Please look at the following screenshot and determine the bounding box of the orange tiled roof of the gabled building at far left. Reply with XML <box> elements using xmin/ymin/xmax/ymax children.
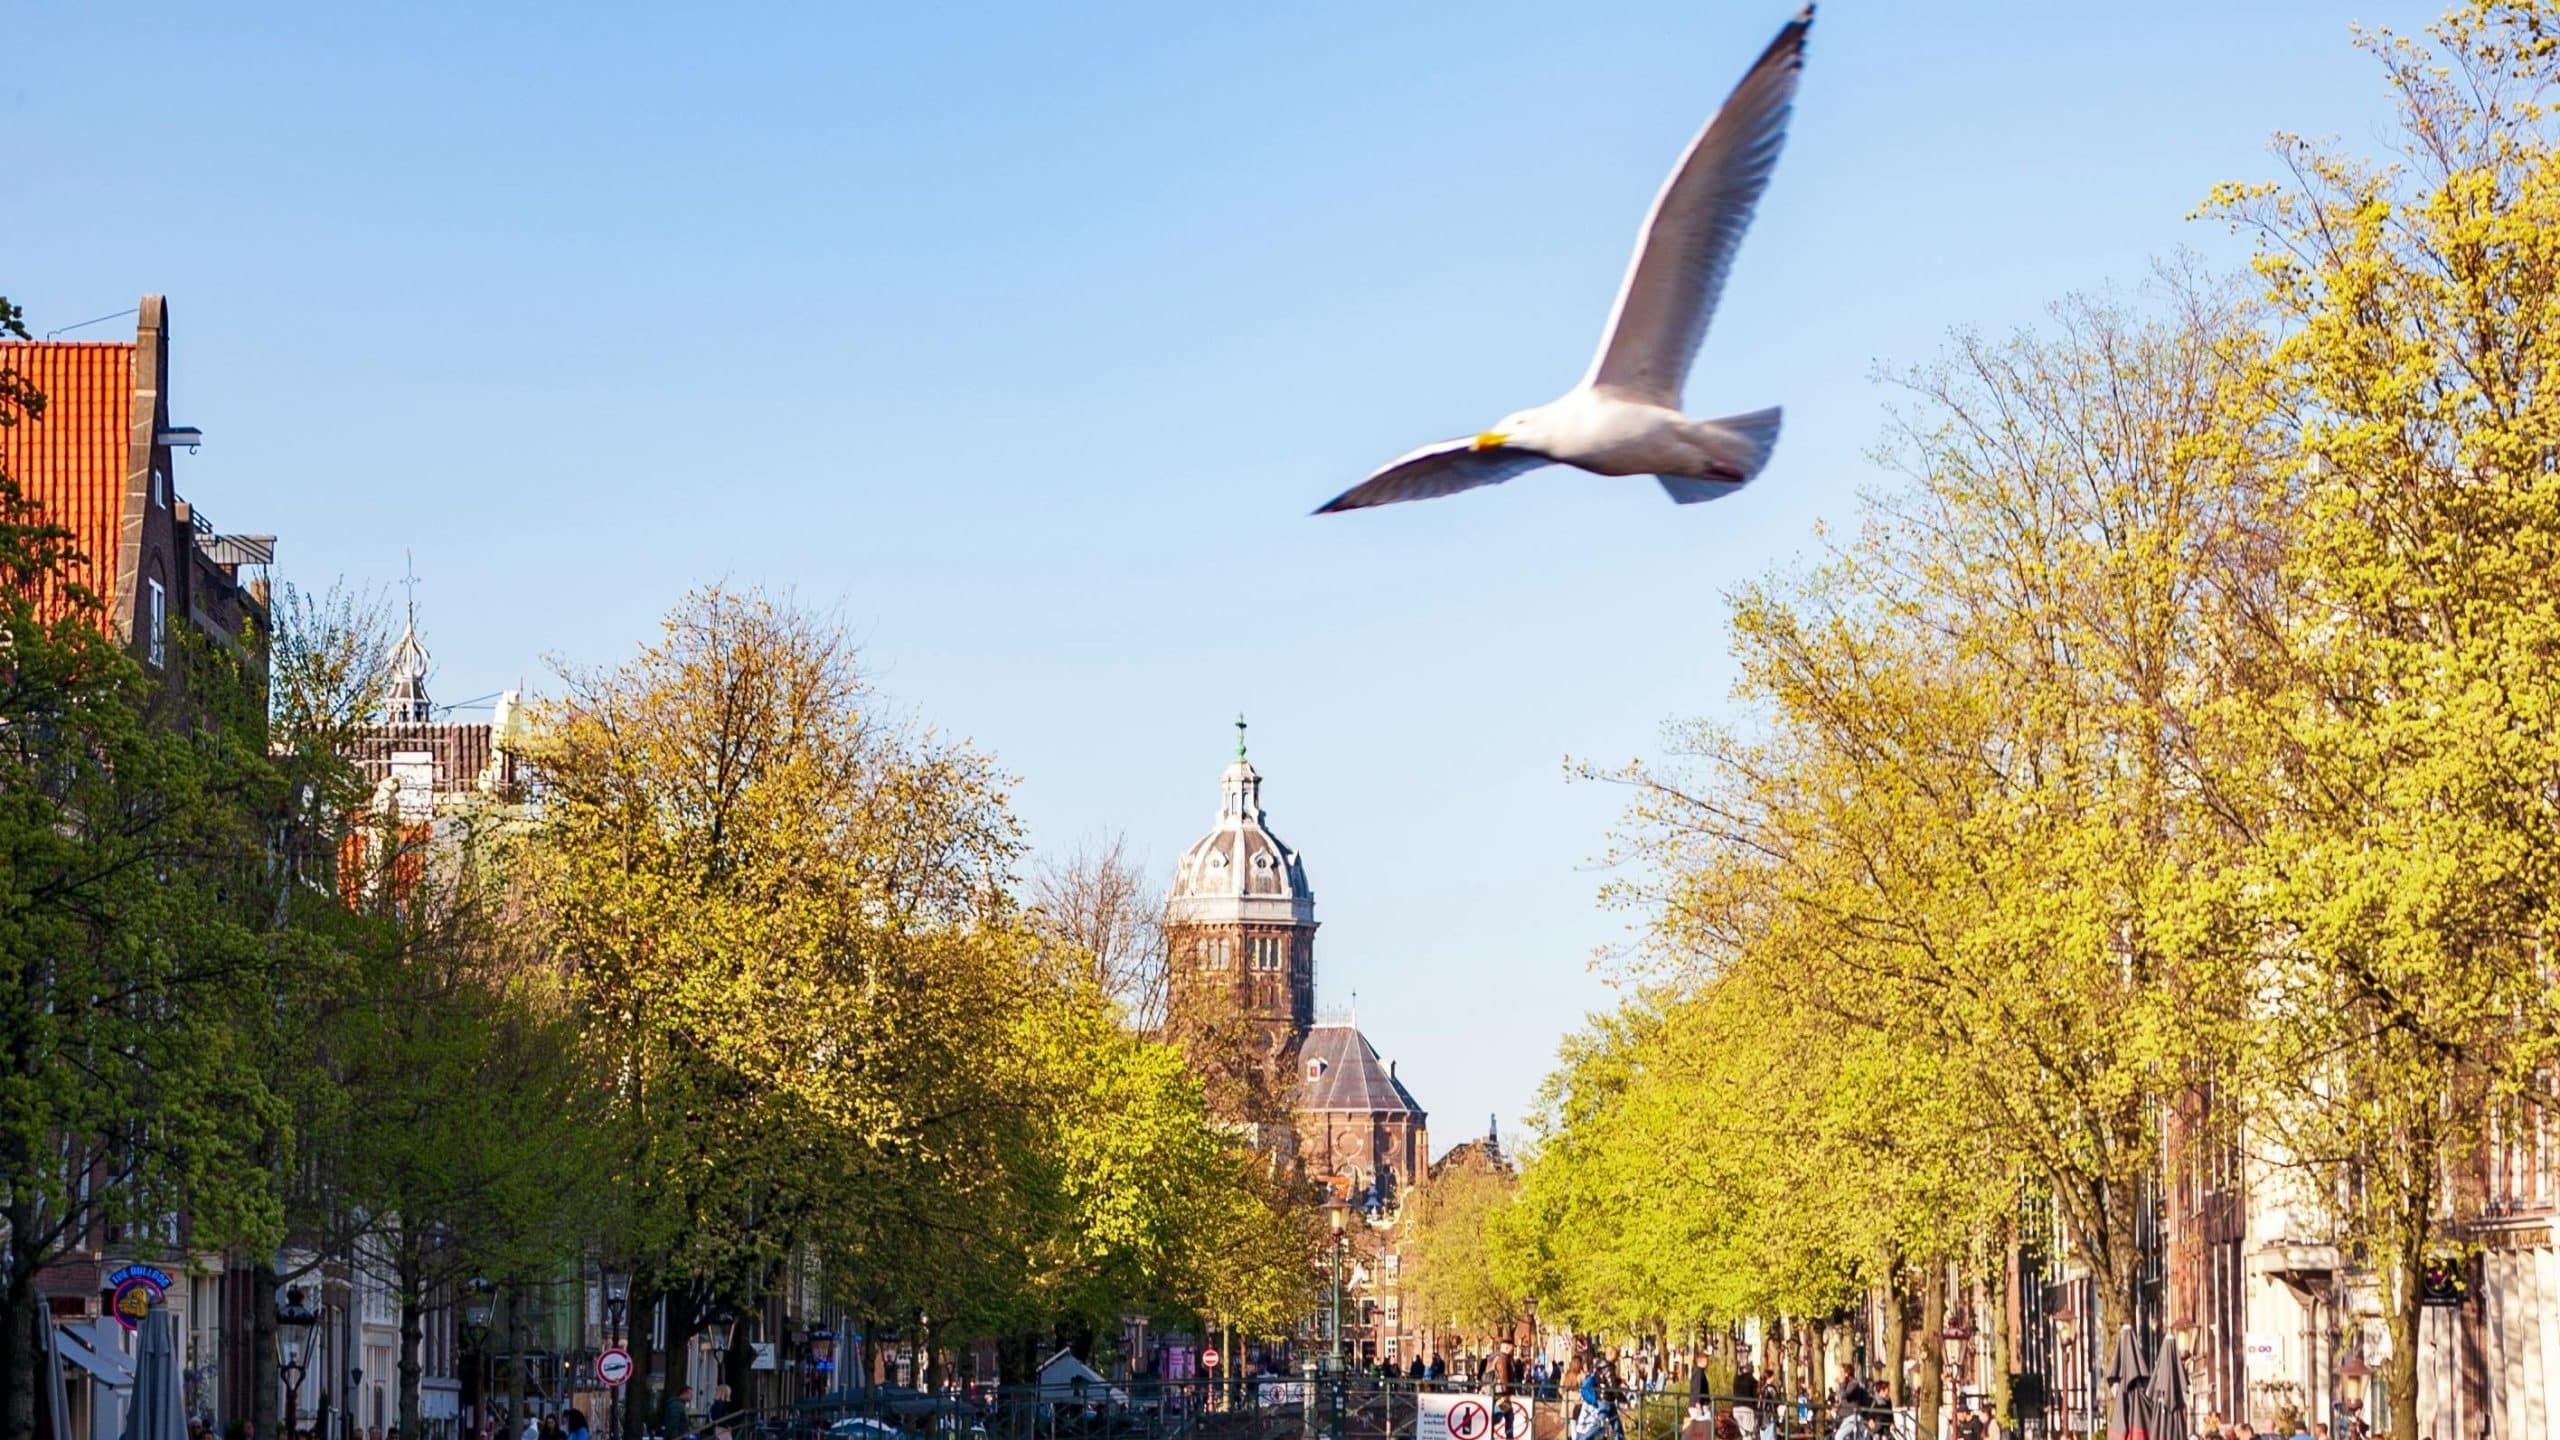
<box><xmin>0</xmin><ymin>341</ymin><xmax>133</xmax><ymax>615</ymax></box>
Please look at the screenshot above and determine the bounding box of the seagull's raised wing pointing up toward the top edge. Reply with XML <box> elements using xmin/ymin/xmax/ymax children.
<box><xmin>1582</xmin><ymin>5</ymin><xmax>1812</xmax><ymax>410</ymax></box>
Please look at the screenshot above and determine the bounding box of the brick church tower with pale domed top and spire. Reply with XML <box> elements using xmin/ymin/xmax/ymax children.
<box><xmin>1165</xmin><ymin>715</ymin><xmax>1316</xmax><ymax>1071</ymax></box>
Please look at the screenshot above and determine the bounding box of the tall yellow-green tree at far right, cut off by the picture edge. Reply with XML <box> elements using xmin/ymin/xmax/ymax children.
<box><xmin>2207</xmin><ymin>0</ymin><xmax>2560</xmax><ymax>1440</ymax></box>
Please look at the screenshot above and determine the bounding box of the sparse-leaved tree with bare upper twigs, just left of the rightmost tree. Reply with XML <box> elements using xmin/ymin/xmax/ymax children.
<box><xmin>1620</xmin><ymin>287</ymin><xmax>2258</xmax><ymax>1327</ymax></box>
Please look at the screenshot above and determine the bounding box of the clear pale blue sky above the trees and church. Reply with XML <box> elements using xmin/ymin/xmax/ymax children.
<box><xmin>0</xmin><ymin>0</ymin><xmax>2437</xmax><ymax>1148</ymax></box>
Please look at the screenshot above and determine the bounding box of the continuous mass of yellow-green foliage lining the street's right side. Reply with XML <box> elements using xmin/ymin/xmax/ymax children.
<box><xmin>1513</xmin><ymin>22</ymin><xmax>2560</xmax><ymax>1435</ymax></box>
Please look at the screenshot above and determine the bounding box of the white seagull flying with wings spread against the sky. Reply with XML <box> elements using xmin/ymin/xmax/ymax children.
<box><xmin>1316</xmin><ymin>5</ymin><xmax>1812</xmax><ymax>515</ymax></box>
